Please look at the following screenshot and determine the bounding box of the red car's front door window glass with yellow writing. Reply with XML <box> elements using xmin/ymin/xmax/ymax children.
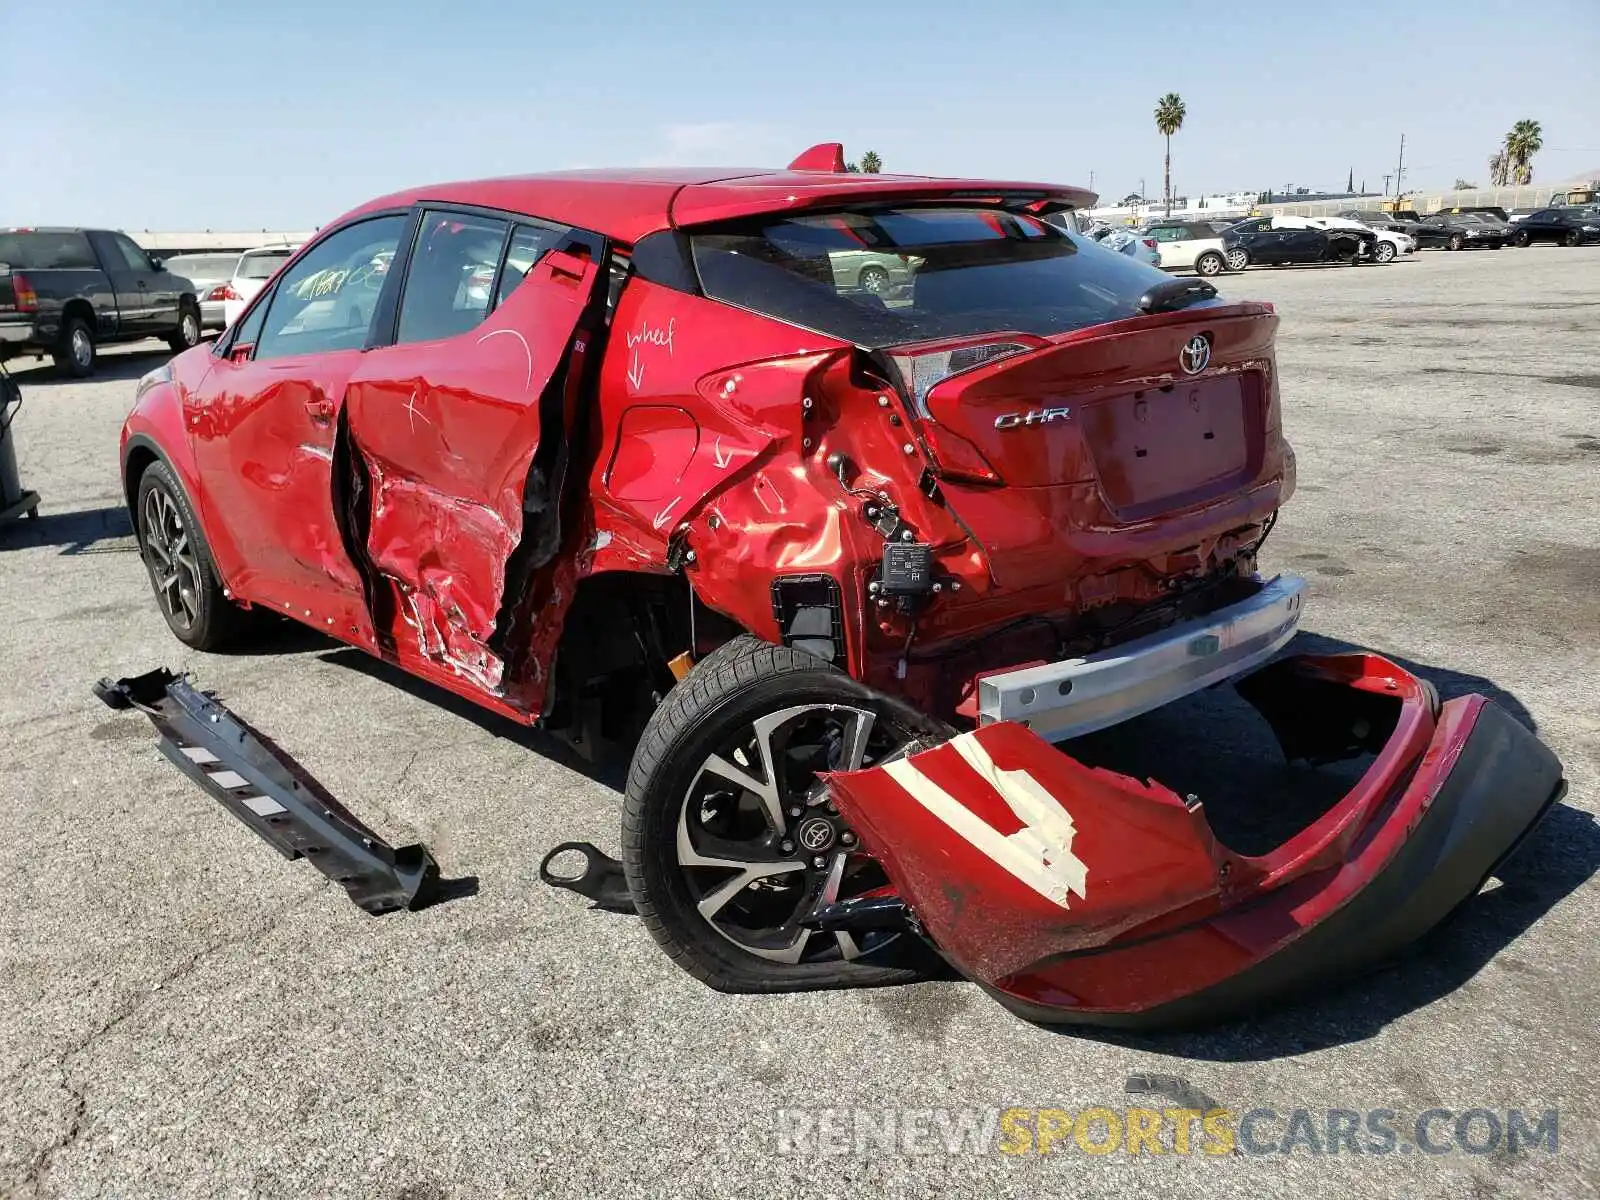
<box><xmin>256</xmin><ymin>216</ymin><xmax>406</xmax><ymax>360</ymax></box>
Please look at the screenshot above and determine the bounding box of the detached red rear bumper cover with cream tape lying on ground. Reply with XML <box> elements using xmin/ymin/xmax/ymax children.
<box><xmin>829</xmin><ymin>654</ymin><xmax>1565</xmax><ymax>1027</ymax></box>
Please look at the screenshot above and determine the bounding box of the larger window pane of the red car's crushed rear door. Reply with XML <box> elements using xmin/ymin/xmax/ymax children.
<box><xmin>395</xmin><ymin>213</ymin><xmax>510</xmax><ymax>344</ymax></box>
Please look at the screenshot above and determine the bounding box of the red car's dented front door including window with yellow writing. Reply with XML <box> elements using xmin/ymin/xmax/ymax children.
<box><xmin>186</xmin><ymin>213</ymin><xmax>408</xmax><ymax>646</ymax></box>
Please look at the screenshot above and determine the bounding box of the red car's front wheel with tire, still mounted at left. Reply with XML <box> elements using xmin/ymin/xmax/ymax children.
<box><xmin>134</xmin><ymin>461</ymin><xmax>251</xmax><ymax>650</ymax></box>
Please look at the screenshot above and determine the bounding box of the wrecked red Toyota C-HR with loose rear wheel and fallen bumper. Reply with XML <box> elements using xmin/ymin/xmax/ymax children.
<box><xmin>122</xmin><ymin>146</ymin><xmax>1562</xmax><ymax>1024</ymax></box>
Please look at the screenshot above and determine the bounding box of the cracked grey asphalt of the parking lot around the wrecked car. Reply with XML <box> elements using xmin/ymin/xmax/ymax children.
<box><xmin>0</xmin><ymin>248</ymin><xmax>1600</xmax><ymax>1200</ymax></box>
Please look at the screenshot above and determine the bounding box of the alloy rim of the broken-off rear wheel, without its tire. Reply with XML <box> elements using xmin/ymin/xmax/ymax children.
<box><xmin>677</xmin><ymin>704</ymin><xmax>910</xmax><ymax>963</ymax></box>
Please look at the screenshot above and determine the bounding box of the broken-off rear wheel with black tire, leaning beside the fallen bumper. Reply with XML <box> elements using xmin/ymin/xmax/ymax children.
<box><xmin>622</xmin><ymin>635</ymin><xmax>950</xmax><ymax>992</ymax></box>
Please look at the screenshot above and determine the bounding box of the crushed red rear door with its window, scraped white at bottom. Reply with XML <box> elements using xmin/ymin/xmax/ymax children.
<box><xmin>347</xmin><ymin>208</ymin><xmax>606</xmax><ymax>714</ymax></box>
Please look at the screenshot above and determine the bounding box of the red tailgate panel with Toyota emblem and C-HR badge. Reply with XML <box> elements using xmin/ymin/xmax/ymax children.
<box><xmin>896</xmin><ymin>304</ymin><xmax>1282</xmax><ymax>587</ymax></box>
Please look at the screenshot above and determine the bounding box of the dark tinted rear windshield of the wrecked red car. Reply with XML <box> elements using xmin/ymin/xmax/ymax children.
<box><xmin>691</xmin><ymin>206</ymin><xmax>1170</xmax><ymax>349</ymax></box>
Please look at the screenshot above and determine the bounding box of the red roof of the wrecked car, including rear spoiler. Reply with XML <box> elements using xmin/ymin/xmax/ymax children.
<box><xmin>341</xmin><ymin>166</ymin><xmax>1096</xmax><ymax>243</ymax></box>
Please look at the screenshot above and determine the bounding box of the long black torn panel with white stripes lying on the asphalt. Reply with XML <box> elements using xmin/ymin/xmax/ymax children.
<box><xmin>94</xmin><ymin>667</ymin><xmax>461</xmax><ymax>915</ymax></box>
